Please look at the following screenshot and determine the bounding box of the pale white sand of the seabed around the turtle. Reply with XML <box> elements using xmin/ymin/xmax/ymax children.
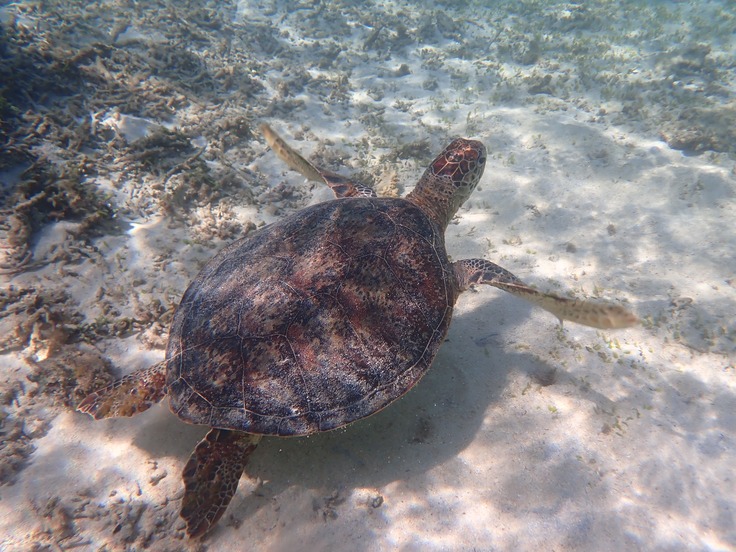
<box><xmin>0</xmin><ymin>1</ymin><xmax>736</xmax><ymax>551</ymax></box>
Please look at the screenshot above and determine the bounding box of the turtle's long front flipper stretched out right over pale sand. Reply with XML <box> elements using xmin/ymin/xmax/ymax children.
<box><xmin>453</xmin><ymin>259</ymin><xmax>639</xmax><ymax>330</ymax></box>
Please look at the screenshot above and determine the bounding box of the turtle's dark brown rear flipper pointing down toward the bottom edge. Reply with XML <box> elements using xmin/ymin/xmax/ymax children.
<box><xmin>179</xmin><ymin>429</ymin><xmax>261</xmax><ymax>538</ymax></box>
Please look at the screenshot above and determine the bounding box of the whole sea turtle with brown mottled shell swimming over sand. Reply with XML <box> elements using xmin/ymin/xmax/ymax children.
<box><xmin>78</xmin><ymin>125</ymin><xmax>637</xmax><ymax>537</ymax></box>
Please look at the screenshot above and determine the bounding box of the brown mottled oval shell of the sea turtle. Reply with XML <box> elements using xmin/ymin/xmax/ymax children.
<box><xmin>166</xmin><ymin>197</ymin><xmax>458</xmax><ymax>435</ymax></box>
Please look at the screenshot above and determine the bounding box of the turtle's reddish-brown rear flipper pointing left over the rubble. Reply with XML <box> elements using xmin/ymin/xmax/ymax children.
<box><xmin>77</xmin><ymin>360</ymin><xmax>166</xmax><ymax>420</ymax></box>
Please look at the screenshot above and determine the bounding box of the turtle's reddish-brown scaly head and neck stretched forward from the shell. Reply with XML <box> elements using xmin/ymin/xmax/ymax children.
<box><xmin>407</xmin><ymin>138</ymin><xmax>486</xmax><ymax>229</ymax></box>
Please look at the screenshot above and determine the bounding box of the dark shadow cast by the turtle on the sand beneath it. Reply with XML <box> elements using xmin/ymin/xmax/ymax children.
<box><xmin>133</xmin><ymin>294</ymin><xmax>556</xmax><ymax>538</ymax></box>
